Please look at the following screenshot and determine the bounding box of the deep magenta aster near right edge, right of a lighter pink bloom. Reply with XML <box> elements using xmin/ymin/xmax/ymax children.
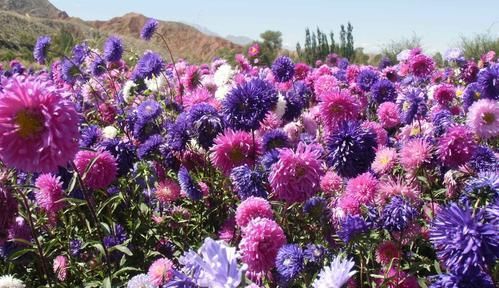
<box><xmin>438</xmin><ymin>126</ymin><xmax>476</xmax><ymax>168</ymax></box>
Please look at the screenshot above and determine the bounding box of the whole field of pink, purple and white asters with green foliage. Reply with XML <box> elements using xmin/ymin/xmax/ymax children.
<box><xmin>0</xmin><ymin>19</ymin><xmax>499</xmax><ymax>288</ymax></box>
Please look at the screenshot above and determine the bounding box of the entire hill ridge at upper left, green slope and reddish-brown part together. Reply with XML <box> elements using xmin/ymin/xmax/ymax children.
<box><xmin>0</xmin><ymin>0</ymin><xmax>242</xmax><ymax>63</ymax></box>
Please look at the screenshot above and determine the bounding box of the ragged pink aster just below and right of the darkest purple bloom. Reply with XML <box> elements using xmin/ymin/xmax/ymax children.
<box><xmin>345</xmin><ymin>172</ymin><xmax>378</xmax><ymax>204</ymax></box>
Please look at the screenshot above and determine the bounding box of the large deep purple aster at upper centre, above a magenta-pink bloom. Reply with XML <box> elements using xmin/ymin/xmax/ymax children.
<box><xmin>222</xmin><ymin>78</ymin><xmax>277</xmax><ymax>131</ymax></box>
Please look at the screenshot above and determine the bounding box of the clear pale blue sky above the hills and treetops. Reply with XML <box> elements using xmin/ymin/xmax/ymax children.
<box><xmin>50</xmin><ymin>0</ymin><xmax>499</xmax><ymax>52</ymax></box>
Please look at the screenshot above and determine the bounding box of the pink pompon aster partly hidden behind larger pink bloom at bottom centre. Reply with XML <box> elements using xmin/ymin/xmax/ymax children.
<box><xmin>236</xmin><ymin>196</ymin><xmax>274</xmax><ymax>227</ymax></box>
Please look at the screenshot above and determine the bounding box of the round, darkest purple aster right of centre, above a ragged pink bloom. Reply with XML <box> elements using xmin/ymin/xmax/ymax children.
<box><xmin>326</xmin><ymin>122</ymin><xmax>376</xmax><ymax>177</ymax></box>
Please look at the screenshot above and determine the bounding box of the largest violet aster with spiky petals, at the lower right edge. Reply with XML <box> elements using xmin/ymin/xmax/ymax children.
<box><xmin>430</xmin><ymin>203</ymin><xmax>499</xmax><ymax>275</ymax></box>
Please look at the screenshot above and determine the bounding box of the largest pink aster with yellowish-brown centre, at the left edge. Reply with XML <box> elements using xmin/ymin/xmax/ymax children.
<box><xmin>0</xmin><ymin>77</ymin><xmax>79</xmax><ymax>172</ymax></box>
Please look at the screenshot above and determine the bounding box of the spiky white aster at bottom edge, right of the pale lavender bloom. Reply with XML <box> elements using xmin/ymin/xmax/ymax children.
<box><xmin>312</xmin><ymin>256</ymin><xmax>357</xmax><ymax>288</ymax></box>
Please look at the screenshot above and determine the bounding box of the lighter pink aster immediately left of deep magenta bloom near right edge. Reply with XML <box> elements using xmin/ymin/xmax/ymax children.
<box><xmin>400</xmin><ymin>138</ymin><xmax>431</xmax><ymax>171</ymax></box>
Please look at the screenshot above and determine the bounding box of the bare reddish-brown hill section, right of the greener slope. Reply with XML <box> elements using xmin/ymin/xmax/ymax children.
<box><xmin>92</xmin><ymin>13</ymin><xmax>242</xmax><ymax>62</ymax></box>
